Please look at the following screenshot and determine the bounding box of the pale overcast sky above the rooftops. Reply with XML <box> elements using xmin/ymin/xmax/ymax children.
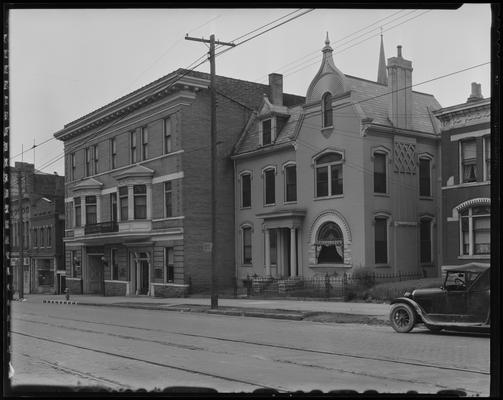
<box><xmin>9</xmin><ymin>3</ymin><xmax>491</xmax><ymax>175</ymax></box>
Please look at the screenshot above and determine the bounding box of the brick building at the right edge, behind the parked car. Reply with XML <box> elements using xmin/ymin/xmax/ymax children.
<box><xmin>435</xmin><ymin>83</ymin><xmax>491</xmax><ymax>265</ymax></box>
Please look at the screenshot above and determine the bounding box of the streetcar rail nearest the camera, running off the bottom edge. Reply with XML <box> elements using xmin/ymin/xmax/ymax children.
<box><xmin>11</xmin><ymin>331</ymin><xmax>288</xmax><ymax>392</ymax></box>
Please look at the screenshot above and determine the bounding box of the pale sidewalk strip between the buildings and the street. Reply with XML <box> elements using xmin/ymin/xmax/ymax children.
<box><xmin>16</xmin><ymin>294</ymin><xmax>390</xmax><ymax>325</ymax></box>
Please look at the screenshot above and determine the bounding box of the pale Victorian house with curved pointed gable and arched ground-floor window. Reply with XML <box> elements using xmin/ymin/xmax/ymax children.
<box><xmin>232</xmin><ymin>36</ymin><xmax>441</xmax><ymax>278</ymax></box>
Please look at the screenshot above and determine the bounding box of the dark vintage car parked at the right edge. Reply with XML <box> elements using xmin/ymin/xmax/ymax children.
<box><xmin>390</xmin><ymin>262</ymin><xmax>490</xmax><ymax>332</ymax></box>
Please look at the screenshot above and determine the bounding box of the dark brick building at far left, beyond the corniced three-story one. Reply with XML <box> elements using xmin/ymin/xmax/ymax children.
<box><xmin>10</xmin><ymin>162</ymin><xmax>64</xmax><ymax>293</ymax></box>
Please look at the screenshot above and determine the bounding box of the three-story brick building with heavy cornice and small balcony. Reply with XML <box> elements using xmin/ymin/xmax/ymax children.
<box><xmin>54</xmin><ymin>70</ymin><xmax>301</xmax><ymax>296</ymax></box>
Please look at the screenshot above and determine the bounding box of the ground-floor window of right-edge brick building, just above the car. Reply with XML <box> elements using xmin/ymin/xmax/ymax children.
<box><xmin>460</xmin><ymin>206</ymin><xmax>491</xmax><ymax>255</ymax></box>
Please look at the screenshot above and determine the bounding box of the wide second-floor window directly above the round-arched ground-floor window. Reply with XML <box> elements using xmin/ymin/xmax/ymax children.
<box><xmin>316</xmin><ymin>153</ymin><xmax>343</xmax><ymax>197</ymax></box>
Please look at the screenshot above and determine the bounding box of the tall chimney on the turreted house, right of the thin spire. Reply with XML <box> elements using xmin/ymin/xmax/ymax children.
<box><xmin>387</xmin><ymin>45</ymin><xmax>412</xmax><ymax>129</ymax></box>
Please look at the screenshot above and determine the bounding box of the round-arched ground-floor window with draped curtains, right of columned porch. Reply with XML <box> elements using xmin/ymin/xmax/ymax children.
<box><xmin>315</xmin><ymin>222</ymin><xmax>344</xmax><ymax>264</ymax></box>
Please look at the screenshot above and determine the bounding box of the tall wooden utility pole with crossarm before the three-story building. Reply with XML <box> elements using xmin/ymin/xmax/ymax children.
<box><xmin>185</xmin><ymin>34</ymin><xmax>235</xmax><ymax>309</ymax></box>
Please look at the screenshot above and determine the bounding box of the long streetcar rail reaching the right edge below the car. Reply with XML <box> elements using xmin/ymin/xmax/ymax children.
<box><xmin>13</xmin><ymin>313</ymin><xmax>490</xmax><ymax>375</ymax></box>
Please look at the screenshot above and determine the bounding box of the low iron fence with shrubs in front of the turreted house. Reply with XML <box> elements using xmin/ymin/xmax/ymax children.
<box><xmin>243</xmin><ymin>272</ymin><xmax>424</xmax><ymax>298</ymax></box>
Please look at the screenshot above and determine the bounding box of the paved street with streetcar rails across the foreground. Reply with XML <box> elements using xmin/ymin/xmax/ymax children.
<box><xmin>7</xmin><ymin>302</ymin><xmax>490</xmax><ymax>396</ymax></box>
